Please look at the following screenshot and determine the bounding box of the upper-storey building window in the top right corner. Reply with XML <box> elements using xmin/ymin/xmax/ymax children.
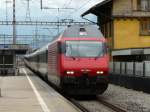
<box><xmin>138</xmin><ymin>0</ymin><xmax>150</xmax><ymax>11</ymax></box>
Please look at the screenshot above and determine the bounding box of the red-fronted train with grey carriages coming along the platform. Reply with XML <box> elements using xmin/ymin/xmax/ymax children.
<box><xmin>24</xmin><ymin>25</ymin><xmax>109</xmax><ymax>95</ymax></box>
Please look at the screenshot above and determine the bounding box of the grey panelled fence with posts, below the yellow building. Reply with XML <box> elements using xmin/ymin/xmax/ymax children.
<box><xmin>110</xmin><ymin>61</ymin><xmax>150</xmax><ymax>77</ymax></box>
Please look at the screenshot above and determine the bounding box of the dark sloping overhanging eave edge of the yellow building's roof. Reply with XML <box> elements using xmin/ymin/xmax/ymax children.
<box><xmin>81</xmin><ymin>0</ymin><xmax>112</xmax><ymax>17</ymax></box>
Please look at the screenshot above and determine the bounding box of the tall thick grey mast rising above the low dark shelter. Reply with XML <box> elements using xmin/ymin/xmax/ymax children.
<box><xmin>13</xmin><ymin>0</ymin><xmax>16</xmax><ymax>44</ymax></box>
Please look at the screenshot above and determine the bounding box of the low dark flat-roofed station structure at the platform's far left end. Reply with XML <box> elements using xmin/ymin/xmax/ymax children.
<box><xmin>0</xmin><ymin>44</ymin><xmax>30</xmax><ymax>75</ymax></box>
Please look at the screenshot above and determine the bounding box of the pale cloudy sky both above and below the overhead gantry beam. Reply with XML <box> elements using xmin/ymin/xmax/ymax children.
<box><xmin>0</xmin><ymin>0</ymin><xmax>103</xmax><ymax>46</ymax></box>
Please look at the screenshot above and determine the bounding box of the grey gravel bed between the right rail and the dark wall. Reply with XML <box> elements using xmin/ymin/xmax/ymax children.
<box><xmin>99</xmin><ymin>84</ymin><xmax>150</xmax><ymax>112</ymax></box>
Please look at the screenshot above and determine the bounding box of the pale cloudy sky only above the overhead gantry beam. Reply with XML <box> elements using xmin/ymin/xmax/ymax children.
<box><xmin>0</xmin><ymin>0</ymin><xmax>102</xmax><ymax>21</ymax></box>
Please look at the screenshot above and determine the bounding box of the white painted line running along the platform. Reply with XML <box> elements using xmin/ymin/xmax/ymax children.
<box><xmin>23</xmin><ymin>68</ymin><xmax>50</xmax><ymax>112</ymax></box>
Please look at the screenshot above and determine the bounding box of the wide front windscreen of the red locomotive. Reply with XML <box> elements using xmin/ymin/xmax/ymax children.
<box><xmin>66</xmin><ymin>41</ymin><xmax>104</xmax><ymax>57</ymax></box>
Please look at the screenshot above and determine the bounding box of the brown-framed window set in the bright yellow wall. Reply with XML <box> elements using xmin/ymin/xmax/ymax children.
<box><xmin>140</xmin><ymin>20</ymin><xmax>150</xmax><ymax>36</ymax></box>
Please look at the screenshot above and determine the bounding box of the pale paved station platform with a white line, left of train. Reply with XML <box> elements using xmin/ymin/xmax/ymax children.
<box><xmin>0</xmin><ymin>68</ymin><xmax>80</xmax><ymax>112</ymax></box>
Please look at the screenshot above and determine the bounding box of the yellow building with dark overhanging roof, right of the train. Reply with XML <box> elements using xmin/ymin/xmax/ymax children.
<box><xmin>82</xmin><ymin>0</ymin><xmax>150</xmax><ymax>61</ymax></box>
